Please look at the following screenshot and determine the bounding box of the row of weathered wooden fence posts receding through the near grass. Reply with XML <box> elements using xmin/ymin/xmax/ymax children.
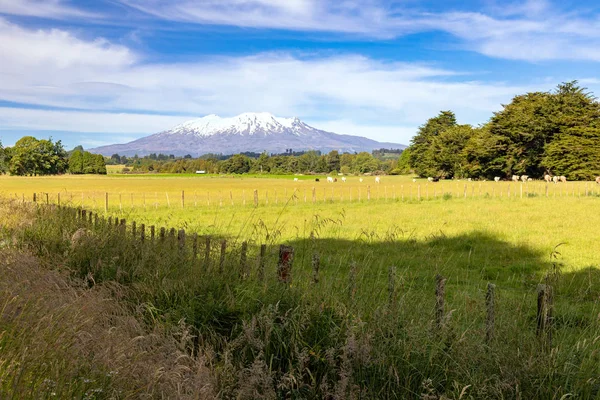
<box><xmin>14</xmin><ymin>202</ymin><xmax>572</xmax><ymax>348</ymax></box>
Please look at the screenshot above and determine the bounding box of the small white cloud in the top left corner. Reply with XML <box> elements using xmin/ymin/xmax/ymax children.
<box><xmin>0</xmin><ymin>0</ymin><xmax>94</xmax><ymax>19</ymax></box>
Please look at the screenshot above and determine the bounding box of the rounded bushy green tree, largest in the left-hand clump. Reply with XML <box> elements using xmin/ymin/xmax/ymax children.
<box><xmin>8</xmin><ymin>136</ymin><xmax>68</xmax><ymax>176</ymax></box>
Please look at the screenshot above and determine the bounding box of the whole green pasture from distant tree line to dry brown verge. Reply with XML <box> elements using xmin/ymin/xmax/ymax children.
<box><xmin>0</xmin><ymin>175</ymin><xmax>600</xmax><ymax>399</ymax></box>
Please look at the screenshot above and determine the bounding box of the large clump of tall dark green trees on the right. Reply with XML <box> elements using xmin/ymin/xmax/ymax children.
<box><xmin>408</xmin><ymin>81</ymin><xmax>600</xmax><ymax>180</ymax></box>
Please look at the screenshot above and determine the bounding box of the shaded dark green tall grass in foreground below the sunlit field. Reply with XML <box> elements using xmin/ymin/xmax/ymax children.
<box><xmin>3</xmin><ymin>202</ymin><xmax>600</xmax><ymax>399</ymax></box>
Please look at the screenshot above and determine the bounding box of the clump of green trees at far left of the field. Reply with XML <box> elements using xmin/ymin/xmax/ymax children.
<box><xmin>0</xmin><ymin>136</ymin><xmax>106</xmax><ymax>176</ymax></box>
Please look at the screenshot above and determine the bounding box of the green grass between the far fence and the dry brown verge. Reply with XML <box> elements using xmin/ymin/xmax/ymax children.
<box><xmin>0</xmin><ymin>177</ymin><xmax>600</xmax><ymax>399</ymax></box>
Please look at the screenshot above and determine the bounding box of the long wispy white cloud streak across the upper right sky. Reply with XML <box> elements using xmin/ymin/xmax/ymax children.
<box><xmin>115</xmin><ymin>0</ymin><xmax>600</xmax><ymax>61</ymax></box>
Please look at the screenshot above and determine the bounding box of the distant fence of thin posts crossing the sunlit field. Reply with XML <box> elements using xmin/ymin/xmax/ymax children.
<box><xmin>8</xmin><ymin>182</ymin><xmax>600</xmax><ymax>213</ymax></box>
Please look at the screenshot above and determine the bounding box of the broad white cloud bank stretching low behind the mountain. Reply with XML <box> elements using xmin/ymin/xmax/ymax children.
<box><xmin>0</xmin><ymin>19</ymin><xmax>547</xmax><ymax>143</ymax></box>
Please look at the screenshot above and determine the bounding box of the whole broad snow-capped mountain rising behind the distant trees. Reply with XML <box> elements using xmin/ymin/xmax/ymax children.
<box><xmin>90</xmin><ymin>113</ymin><xmax>406</xmax><ymax>156</ymax></box>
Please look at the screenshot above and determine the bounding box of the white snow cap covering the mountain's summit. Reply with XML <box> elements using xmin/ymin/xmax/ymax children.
<box><xmin>165</xmin><ymin>112</ymin><xmax>307</xmax><ymax>136</ymax></box>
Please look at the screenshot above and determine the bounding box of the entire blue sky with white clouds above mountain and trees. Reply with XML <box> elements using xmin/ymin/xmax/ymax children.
<box><xmin>0</xmin><ymin>0</ymin><xmax>600</xmax><ymax>148</ymax></box>
